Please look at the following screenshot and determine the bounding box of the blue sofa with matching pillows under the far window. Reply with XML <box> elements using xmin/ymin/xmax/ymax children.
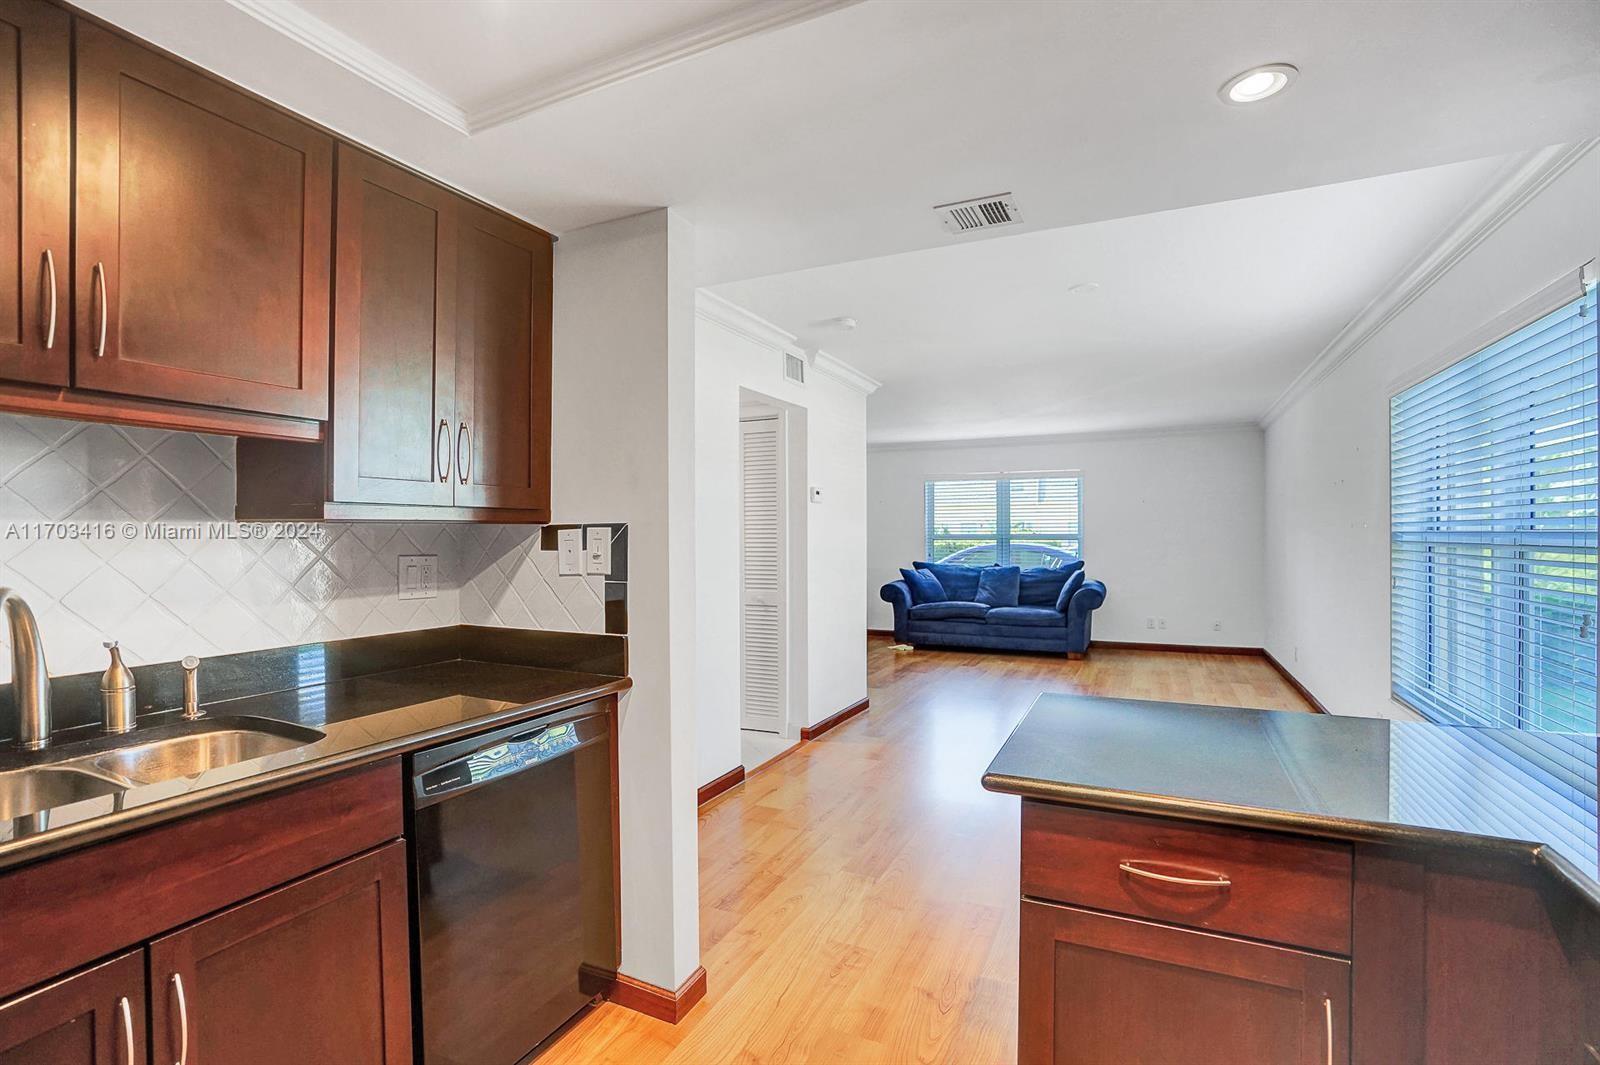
<box><xmin>878</xmin><ymin>558</ymin><xmax>1106</xmax><ymax>659</ymax></box>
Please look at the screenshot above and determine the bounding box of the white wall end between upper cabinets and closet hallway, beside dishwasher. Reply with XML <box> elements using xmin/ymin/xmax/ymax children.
<box><xmin>550</xmin><ymin>211</ymin><xmax>699</xmax><ymax>988</ymax></box>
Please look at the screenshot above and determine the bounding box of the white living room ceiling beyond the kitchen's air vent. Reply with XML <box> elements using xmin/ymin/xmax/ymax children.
<box><xmin>714</xmin><ymin>158</ymin><xmax>1509</xmax><ymax>443</ymax></box>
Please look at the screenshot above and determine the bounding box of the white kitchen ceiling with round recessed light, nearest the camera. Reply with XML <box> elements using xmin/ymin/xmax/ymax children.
<box><xmin>78</xmin><ymin>0</ymin><xmax>1600</xmax><ymax>283</ymax></box>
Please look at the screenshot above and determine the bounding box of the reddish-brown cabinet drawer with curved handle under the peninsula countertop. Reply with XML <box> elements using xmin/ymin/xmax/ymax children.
<box><xmin>1022</xmin><ymin>801</ymin><xmax>1350</xmax><ymax>955</ymax></box>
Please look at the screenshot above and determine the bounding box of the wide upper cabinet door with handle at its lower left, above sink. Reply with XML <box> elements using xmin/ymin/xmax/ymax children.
<box><xmin>72</xmin><ymin>19</ymin><xmax>333</xmax><ymax>419</ymax></box>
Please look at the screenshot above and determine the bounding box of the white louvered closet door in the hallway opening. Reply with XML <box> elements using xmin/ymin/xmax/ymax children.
<box><xmin>739</xmin><ymin>417</ymin><xmax>787</xmax><ymax>732</ymax></box>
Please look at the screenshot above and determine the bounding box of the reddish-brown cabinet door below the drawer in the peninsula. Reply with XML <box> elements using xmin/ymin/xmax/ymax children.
<box><xmin>1018</xmin><ymin>900</ymin><xmax>1350</xmax><ymax>1065</ymax></box>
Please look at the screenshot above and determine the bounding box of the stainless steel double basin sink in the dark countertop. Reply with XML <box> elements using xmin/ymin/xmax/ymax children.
<box><xmin>0</xmin><ymin>716</ymin><xmax>323</xmax><ymax>820</ymax></box>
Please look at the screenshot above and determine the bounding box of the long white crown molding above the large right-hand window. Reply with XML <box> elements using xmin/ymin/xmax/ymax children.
<box><xmin>1261</xmin><ymin>138</ymin><xmax>1600</xmax><ymax>427</ymax></box>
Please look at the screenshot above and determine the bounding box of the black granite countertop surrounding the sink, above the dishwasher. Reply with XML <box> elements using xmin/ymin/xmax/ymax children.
<box><xmin>0</xmin><ymin>627</ymin><xmax>632</xmax><ymax>868</ymax></box>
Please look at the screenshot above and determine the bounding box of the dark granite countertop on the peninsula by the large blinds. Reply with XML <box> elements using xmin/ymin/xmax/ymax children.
<box><xmin>984</xmin><ymin>694</ymin><xmax>1600</xmax><ymax>908</ymax></box>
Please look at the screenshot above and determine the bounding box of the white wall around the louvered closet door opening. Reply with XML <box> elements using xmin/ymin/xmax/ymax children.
<box><xmin>694</xmin><ymin>294</ymin><xmax>867</xmax><ymax>784</ymax></box>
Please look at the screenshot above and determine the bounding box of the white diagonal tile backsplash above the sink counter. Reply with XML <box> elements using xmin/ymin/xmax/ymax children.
<box><xmin>0</xmin><ymin>414</ymin><xmax>617</xmax><ymax>680</ymax></box>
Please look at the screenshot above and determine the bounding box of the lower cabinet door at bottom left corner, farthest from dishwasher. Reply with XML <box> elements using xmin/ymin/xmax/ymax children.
<box><xmin>0</xmin><ymin>950</ymin><xmax>146</xmax><ymax>1065</ymax></box>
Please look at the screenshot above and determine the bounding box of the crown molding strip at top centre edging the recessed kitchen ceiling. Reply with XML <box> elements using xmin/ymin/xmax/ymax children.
<box><xmin>464</xmin><ymin>0</ymin><xmax>861</xmax><ymax>133</ymax></box>
